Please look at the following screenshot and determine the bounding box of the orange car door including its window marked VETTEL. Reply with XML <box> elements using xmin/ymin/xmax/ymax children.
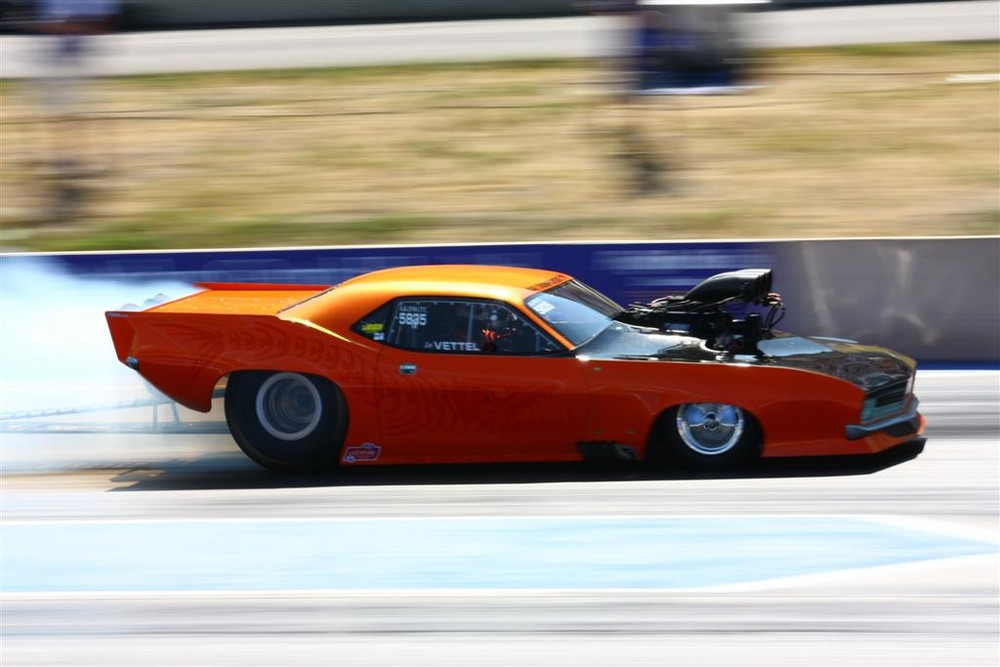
<box><xmin>376</xmin><ymin>297</ymin><xmax>586</xmax><ymax>462</ymax></box>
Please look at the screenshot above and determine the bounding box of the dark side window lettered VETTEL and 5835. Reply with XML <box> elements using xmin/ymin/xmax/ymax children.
<box><xmin>383</xmin><ymin>298</ymin><xmax>561</xmax><ymax>355</ymax></box>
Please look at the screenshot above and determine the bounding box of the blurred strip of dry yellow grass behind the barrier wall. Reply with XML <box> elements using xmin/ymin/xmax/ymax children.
<box><xmin>0</xmin><ymin>44</ymin><xmax>1000</xmax><ymax>250</ymax></box>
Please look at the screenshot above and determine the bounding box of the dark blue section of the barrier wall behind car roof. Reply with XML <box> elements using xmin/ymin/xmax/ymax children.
<box><xmin>5</xmin><ymin>242</ymin><xmax>774</xmax><ymax>303</ymax></box>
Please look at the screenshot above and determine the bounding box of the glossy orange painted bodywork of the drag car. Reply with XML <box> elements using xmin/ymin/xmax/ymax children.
<box><xmin>107</xmin><ymin>266</ymin><xmax>923</xmax><ymax>465</ymax></box>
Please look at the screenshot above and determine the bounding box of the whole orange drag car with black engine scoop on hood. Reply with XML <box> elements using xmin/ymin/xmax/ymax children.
<box><xmin>106</xmin><ymin>266</ymin><xmax>923</xmax><ymax>470</ymax></box>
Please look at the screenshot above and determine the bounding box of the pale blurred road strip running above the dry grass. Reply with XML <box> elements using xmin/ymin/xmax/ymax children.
<box><xmin>0</xmin><ymin>0</ymin><xmax>1000</xmax><ymax>79</ymax></box>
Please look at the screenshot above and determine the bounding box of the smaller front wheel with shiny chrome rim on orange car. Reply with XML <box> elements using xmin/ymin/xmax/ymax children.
<box><xmin>650</xmin><ymin>403</ymin><xmax>763</xmax><ymax>468</ymax></box>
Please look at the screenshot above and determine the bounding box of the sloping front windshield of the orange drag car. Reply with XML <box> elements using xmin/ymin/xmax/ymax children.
<box><xmin>525</xmin><ymin>280</ymin><xmax>622</xmax><ymax>347</ymax></box>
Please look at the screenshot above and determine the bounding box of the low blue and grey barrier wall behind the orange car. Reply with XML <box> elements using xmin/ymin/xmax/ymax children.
<box><xmin>0</xmin><ymin>237</ymin><xmax>1000</xmax><ymax>364</ymax></box>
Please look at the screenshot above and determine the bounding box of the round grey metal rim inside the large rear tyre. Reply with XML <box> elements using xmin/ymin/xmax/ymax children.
<box><xmin>256</xmin><ymin>373</ymin><xmax>323</xmax><ymax>442</ymax></box>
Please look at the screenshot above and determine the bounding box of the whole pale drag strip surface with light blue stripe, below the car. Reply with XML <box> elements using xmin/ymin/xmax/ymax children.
<box><xmin>0</xmin><ymin>371</ymin><xmax>1000</xmax><ymax>667</ymax></box>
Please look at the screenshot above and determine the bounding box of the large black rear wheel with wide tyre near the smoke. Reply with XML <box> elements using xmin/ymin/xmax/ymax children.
<box><xmin>225</xmin><ymin>371</ymin><xmax>347</xmax><ymax>471</ymax></box>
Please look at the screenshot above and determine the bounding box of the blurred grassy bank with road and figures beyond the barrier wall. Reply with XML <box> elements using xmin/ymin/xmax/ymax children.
<box><xmin>0</xmin><ymin>0</ymin><xmax>1000</xmax><ymax>251</ymax></box>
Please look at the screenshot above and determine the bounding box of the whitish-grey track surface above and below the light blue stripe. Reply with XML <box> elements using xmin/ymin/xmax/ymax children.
<box><xmin>3</xmin><ymin>438</ymin><xmax>998</xmax><ymax>667</ymax></box>
